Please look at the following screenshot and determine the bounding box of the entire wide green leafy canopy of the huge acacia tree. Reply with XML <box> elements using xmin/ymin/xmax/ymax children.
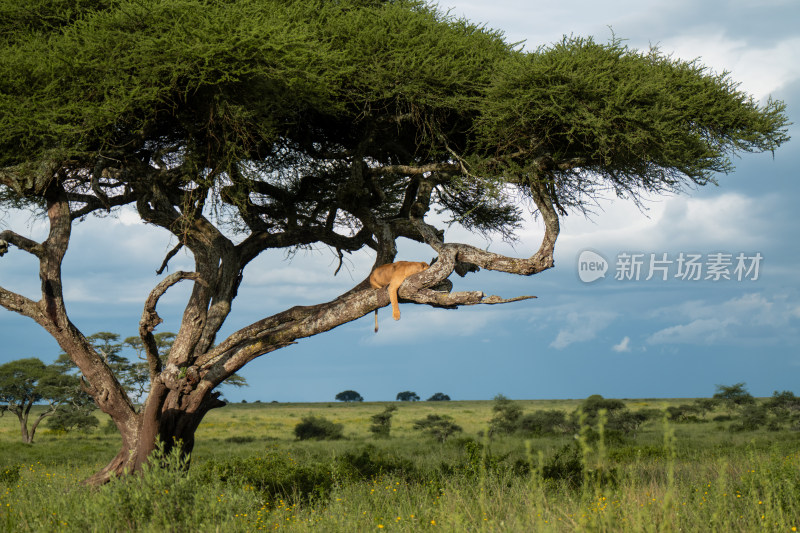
<box><xmin>0</xmin><ymin>0</ymin><xmax>788</xmax><ymax>236</ymax></box>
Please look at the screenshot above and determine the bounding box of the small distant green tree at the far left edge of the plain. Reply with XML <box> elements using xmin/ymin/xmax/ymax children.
<box><xmin>0</xmin><ymin>358</ymin><xmax>81</xmax><ymax>443</ymax></box>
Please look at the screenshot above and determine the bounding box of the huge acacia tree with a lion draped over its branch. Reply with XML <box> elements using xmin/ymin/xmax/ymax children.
<box><xmin>0</xmin><ymin>0</ymin><xmax>787</xmax><ymax>483</ymax></box>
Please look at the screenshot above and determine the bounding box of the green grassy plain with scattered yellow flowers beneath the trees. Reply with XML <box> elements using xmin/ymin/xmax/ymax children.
<box><xmin>0</xmin><ymin>399</ymin><xmax>800</xmax><ymax>532</ymax></box>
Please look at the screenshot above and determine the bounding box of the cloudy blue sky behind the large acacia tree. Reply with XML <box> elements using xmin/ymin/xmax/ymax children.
<box><xmin>0</xmin><ymin>0</ymin><xmax>800</xmax><ymax>402</ymax></box>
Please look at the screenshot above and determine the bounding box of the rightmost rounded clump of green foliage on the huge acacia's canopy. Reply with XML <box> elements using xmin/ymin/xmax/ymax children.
<box><xmin>479</xmin><ymin>37</ymin><xmax>788</xmax><ymax>206</ymax></box>
